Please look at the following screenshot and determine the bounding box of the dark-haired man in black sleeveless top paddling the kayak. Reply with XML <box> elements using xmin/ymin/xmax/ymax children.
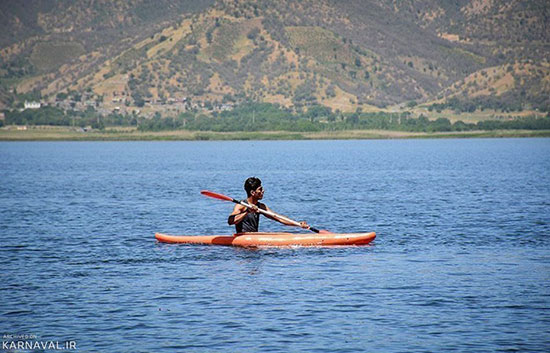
<box><xmin>227</xmin><ymin>177</ymin><xmax>309</xmax><ymax>233</ymax></box>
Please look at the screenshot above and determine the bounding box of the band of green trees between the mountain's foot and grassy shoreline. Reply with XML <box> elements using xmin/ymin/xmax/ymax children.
<box><xmin>5</xmin><ymin>103</ymin><xmax>550</xmax><ymax>139</ymax></box>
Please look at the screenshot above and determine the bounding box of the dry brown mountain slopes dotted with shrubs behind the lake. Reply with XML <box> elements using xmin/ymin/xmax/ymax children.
<box><xmin>0</xmin><ymin>0</ymin><xmax>550</xmax><ymax>111</ymax></box>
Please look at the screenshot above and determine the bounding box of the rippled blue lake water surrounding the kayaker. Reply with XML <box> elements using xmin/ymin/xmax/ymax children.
<box><xmin>0</xmin><ymin>139</ymin><xmax>550</xmax><ymax>352</ymax></box>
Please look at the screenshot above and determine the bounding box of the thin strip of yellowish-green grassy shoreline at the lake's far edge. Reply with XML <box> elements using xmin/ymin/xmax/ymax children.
<box><xmin>0</xmin><ymin>127</ymin><xmax>550</xmax><ymax>141</ymax></box>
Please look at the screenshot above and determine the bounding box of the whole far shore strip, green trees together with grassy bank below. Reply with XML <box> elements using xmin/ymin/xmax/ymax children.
<box><xmin>0</xmin><ymin>103</ymin><xmax>550</xmax><ymax>140</ymax></box>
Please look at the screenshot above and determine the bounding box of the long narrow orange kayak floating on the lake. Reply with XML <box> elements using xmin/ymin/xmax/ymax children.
<box><xmin>155</xmin><ymin>232</ymin><xmax>376</xmax><ymax>247</ymax></box>
